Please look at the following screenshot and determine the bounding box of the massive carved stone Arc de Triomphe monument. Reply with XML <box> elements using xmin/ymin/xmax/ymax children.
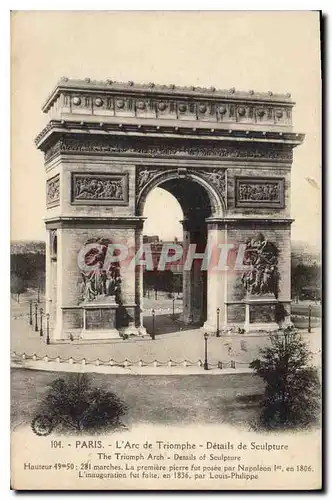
<box><xmin>36</xmin><ymin>78</ymin><xmax>304</xmax><ymax>342</ymax></box>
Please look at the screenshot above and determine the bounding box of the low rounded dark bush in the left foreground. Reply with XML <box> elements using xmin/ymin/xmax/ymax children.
<box><xmin>38</xmin><ymin>373</ymin><xmax>126</xmax><ymax>433</ymax></box>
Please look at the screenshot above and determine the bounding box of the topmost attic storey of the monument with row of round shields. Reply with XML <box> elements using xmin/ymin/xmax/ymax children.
<box><xmin>38</xmin><ymin>78</ymin><xmax>294</xmax><ymax>128</ymax></box>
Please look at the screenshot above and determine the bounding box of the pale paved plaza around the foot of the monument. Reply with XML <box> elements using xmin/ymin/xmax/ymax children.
<box><xmin>11</xmin><ymin>295</ymin><xmax>321</xmax><ymax>373</ymax></box>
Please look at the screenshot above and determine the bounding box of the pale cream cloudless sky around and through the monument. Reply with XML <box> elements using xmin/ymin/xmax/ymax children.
<box><xmin>11</xmin><ymin>11</ymin><xmax>321</xmax><ymax>246</ymax></box>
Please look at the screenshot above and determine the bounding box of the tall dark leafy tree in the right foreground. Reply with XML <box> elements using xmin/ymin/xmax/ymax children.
<box><xmin>250</xmin><ymin>327</ymin><xmax>320</xmax><ymax>428</ymax></box>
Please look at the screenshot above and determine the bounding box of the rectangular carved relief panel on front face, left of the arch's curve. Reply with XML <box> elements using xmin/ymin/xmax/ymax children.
<box><xmin>71</xmin><ymin>172</ymin><xmax>128</xmax><ymax>205</ymax></box>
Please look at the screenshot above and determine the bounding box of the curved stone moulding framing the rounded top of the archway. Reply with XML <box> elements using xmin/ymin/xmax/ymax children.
<box><xmin>136</xmin><ymin>168</ymin><xmax>226</xmax><ymax>217</ymax></box>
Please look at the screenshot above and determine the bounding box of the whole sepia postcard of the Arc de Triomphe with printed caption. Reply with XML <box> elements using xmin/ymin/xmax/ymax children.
<box><xmin>10</xmin><ymin>11</ymin><xmax>322</xmax><ymax>491</ymax></box>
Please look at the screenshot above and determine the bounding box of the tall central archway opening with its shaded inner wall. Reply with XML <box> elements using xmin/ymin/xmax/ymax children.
<box><xmin>142</xmin><ymin>178</ymin><xmax>212</xmax><ymax>335</ymax></box>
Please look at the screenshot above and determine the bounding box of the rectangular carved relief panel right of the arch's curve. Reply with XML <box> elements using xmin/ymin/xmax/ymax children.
<box><xmin>235</xmin><ymin>177</ymin><xmax>285</xmax><ymax>208</ymax></box>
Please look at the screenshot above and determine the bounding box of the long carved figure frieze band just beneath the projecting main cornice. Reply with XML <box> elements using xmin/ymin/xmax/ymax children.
<box><xmin>41</xmin><ymin>136</ymin><xmax>293</xmax><ymax>163</ymax></box>
